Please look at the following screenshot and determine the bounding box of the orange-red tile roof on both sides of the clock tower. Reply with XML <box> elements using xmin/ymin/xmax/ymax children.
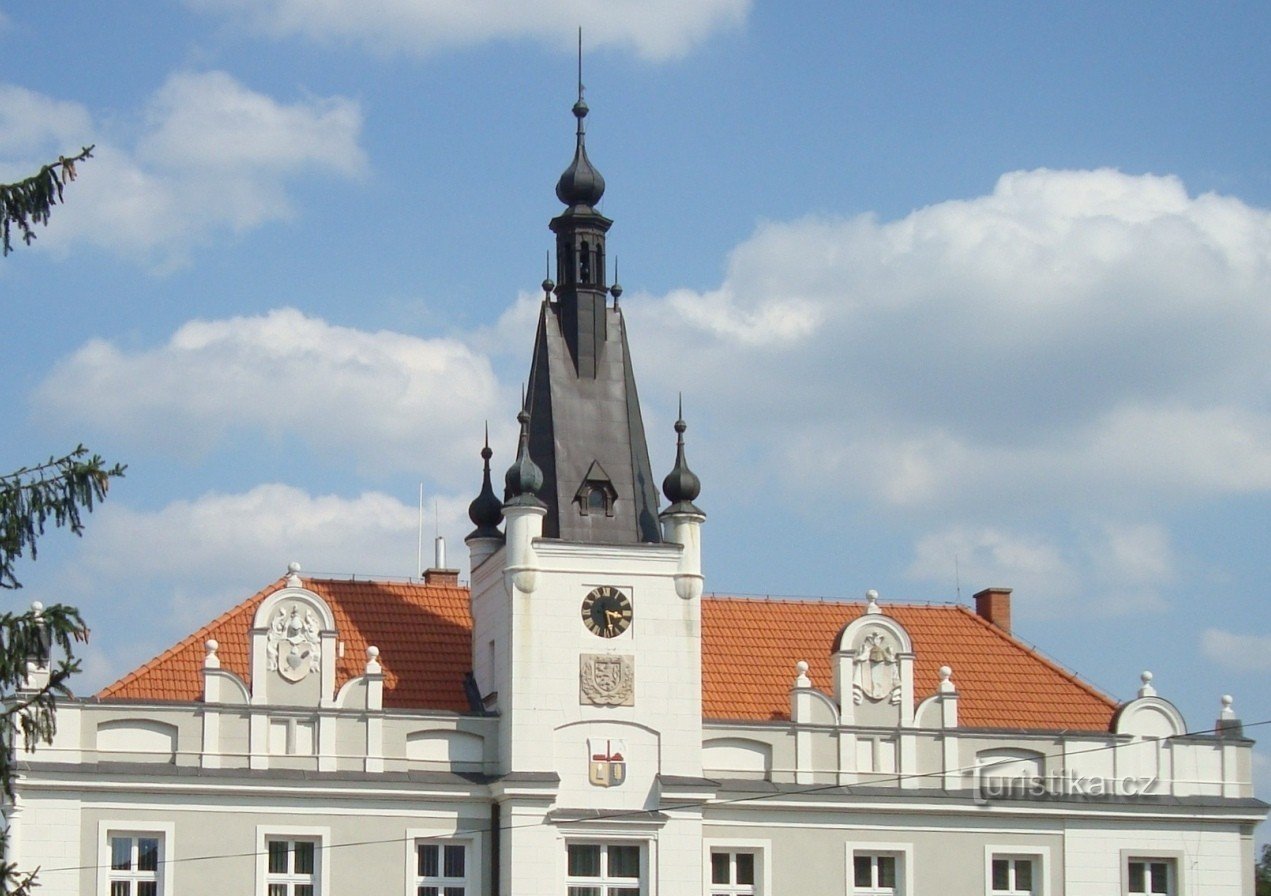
<box><xmin>98</xmin><ymin>578</ymin><xmax>1116</xmax><ymax>731</ymax></box>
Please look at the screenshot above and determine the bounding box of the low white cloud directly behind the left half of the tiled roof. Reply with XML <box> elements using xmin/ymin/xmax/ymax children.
<box><xmin>46</xmin><ymin>483</ymin><xmax>470</xmax><ymax>693</ymax></box>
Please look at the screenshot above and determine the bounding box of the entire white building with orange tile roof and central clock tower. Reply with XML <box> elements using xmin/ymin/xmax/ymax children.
<box><xmin>8</xmin><ymin>85</ymin><xmax>1267</xmax><ymax>896</ymax></box>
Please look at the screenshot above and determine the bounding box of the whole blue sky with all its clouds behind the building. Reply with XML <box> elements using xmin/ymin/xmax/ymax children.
<box><xmin>0</xmin><ymin>0</ymin><xmax>1271</xmax><ymax>823</ymax></box>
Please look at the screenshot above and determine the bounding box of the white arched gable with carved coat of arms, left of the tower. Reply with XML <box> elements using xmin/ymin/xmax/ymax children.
<box><xmin>249</xmin><ymin>563</ymin><xmax>336</xmax><ymax>707</ymax></box>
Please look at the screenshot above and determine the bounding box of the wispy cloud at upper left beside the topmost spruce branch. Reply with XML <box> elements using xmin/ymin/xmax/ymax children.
<box><xmin>0</xmin><ymin>71</ymin><xmax>366</xmax><ymax>268</ymax></box>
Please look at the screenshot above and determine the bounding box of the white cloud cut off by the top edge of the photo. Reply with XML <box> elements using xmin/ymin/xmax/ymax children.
<box><xmin>187</xmin><ymin>0</ymin><xmax>750</xmax><ymax>60</ymax></box>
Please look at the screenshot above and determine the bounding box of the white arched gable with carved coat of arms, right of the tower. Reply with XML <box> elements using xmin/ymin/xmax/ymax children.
<box><xmin>834</xmin><ymin>591</ymin><xmax>914</xmax><ymax>727</ymax></box>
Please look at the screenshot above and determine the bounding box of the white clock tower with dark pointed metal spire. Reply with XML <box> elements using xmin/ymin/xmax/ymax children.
<box><xmin>466</xmin><ymin>78</ymin><xmax>708</xmax><ymax>895</ymax></box>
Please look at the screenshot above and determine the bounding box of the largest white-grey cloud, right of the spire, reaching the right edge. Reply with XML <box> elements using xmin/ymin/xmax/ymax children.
<box><xmin>627</xmin><ymin>170</ymin><xmax>1271</xmax><ymax>516</ymax></box>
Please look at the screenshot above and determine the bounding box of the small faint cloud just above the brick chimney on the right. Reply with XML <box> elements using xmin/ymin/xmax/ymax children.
<box><xmin>906</xmin><ymin>521</ymin><xmax>1176</xmax><ymax>619</ymax></box>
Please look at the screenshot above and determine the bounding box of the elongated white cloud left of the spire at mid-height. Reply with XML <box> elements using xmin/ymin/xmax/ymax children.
<box><xmin>34</xmin><ymin>309</ymin><xmax>505</xmax><ymax>480</ymax></box>
